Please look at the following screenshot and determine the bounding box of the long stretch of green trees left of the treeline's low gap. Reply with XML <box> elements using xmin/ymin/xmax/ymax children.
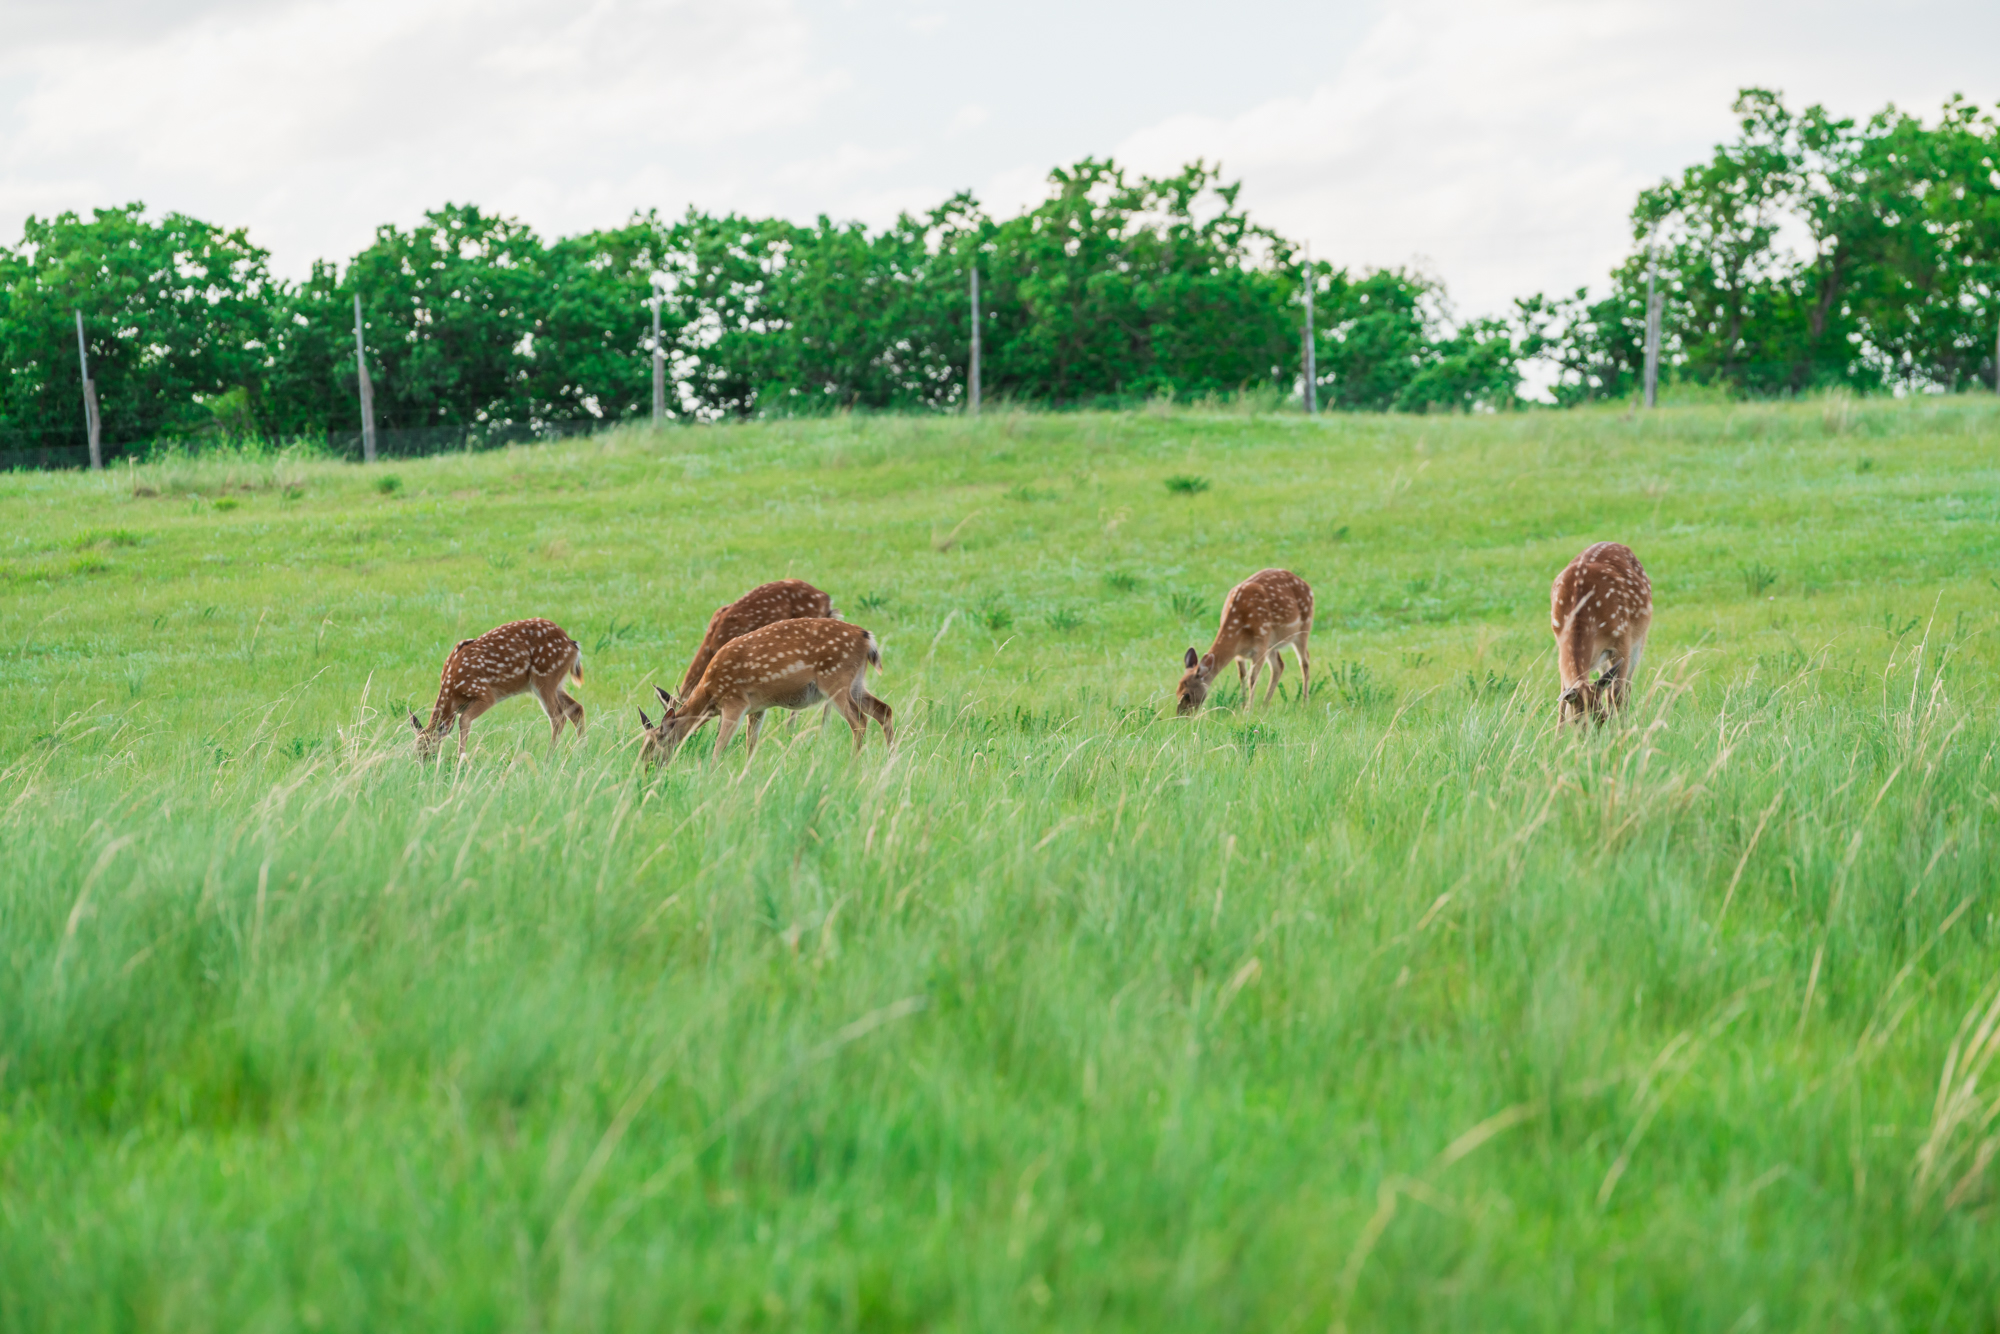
<box><xmin>0</xmin><ymin>160</ymin><xmax>1514</xmax><ymax>444</ymax></box>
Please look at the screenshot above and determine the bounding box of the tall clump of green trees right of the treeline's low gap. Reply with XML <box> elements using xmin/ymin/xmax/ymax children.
<box><xmin>1514</xmin><ymin>90</ymin><xmax>2000</xmax><ymax>402</ymax></box>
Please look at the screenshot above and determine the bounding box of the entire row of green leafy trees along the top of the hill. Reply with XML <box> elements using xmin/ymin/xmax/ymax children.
<box><xmin>0</xmin><ymin>92</ymin><xmax>2000</xmax><ymax>448</ymax></box>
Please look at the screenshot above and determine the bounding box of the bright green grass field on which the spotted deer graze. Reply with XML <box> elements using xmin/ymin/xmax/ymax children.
<box><xmin>0</xmin><ymin>398</ymin><xmax>2000</xmax><ymax>1332</ymax></box>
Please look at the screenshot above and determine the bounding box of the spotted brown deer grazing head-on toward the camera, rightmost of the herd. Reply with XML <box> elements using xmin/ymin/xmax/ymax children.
<box><xmin>1548</xmin><ymin>542</ymin><xmax>1652</xmax><ymax>722</ymax></box>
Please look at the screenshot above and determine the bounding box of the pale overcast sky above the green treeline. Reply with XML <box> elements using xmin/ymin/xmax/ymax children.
<box><xmin>0</xmin><ymin>0</ymin><xmax>2000</xmax><ymax>314</ymax></box>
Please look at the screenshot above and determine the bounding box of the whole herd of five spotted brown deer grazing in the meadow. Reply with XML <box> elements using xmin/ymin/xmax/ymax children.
<box><xmin>410</xmin><ymin>542</ymin><xmax>1652</xmax><ymax>764</ymax></box>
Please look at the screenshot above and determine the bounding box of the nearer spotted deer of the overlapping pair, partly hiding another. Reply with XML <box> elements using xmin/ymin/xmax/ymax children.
<box><xmin>638</xmin><ymin>616</ymin><xmax>896</xmax><ymax>764</ymax></box>
